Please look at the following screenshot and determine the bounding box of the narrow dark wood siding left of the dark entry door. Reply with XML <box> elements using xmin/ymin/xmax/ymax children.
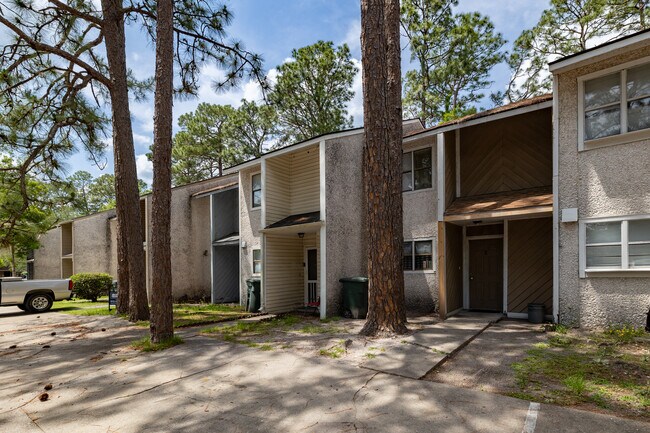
<box><xmin>445</xmin><ymin>223</ymin><xmax>463</xmax><ymax>313</ymax></box>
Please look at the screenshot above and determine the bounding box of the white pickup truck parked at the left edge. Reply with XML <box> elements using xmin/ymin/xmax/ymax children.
<box><xmin>0</xmin><ymin>277</ymin><xmax>73</xmax><ymax>313</ymax></box>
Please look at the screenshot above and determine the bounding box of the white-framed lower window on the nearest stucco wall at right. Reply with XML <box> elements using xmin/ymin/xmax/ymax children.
<box><xmin>584</xmin><ymin>218</ymin><xmax>650</xmax><ymax>271</ymax></box>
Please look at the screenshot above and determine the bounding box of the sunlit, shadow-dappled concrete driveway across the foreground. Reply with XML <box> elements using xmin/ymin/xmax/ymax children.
<box><xmin>0</xmin><ymin>308</ymin><xmax>648</xmax><ymax>433</ymax></box>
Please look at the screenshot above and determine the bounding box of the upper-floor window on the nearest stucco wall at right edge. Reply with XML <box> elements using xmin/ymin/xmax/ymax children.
<box><xmin>582</xmin><ymin>63</ymin><xmax>650</xmax><ymax>141</ymax></box>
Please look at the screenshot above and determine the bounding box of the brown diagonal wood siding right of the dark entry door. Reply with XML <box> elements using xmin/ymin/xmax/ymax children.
<box><xmin>508</xmin><ymin>218</ymin><xmax>553</xmax><ymax>313</ymax></box>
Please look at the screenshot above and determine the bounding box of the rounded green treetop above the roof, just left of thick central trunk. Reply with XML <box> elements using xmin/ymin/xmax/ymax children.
<box><xmin>269</xmin><ymin>41</ymin><xmax>358</xmax><ymax>144</ymax></box>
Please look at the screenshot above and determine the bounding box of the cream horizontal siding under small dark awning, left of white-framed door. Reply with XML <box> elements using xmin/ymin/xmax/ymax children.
<box><xmin>264</xmin><ymin>235</ymin><xmax>305</xmax><ymax>313</ymax></box>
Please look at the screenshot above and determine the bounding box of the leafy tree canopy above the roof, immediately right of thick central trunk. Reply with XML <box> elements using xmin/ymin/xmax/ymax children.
<box><xmin>401</xmin><ymin>0</ymin><xmax>505</xmax><ymax>125</ymax></box>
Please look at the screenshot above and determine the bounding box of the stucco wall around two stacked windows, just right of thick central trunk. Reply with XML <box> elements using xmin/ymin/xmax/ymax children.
<box><xmin>402</xmin><ymin>137</ymin><xmax>438</xmax><ymax>312</ymax></box>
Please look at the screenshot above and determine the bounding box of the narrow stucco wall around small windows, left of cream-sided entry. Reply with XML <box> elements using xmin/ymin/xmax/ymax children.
<box><xmin>239</xmin><ymin>164</ymin><xmax>262</xmax><ymax>305</ymax></box>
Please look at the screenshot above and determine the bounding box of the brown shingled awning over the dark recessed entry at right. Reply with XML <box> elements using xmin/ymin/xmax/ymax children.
<box><xmin>445</xmin><ymin>186</ymin><xmax>553</xmax><ymax>222</ymax></box>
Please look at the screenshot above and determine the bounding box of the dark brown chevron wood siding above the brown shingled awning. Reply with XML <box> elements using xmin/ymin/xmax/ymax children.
<box><xmin>460</xmin><ymin>108</ymin><xmax>552</xmax><ymax>197</ymax></box>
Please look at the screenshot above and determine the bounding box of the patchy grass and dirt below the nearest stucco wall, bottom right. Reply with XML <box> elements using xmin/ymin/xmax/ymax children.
<box><xmin>508</xmin><ymin>326</ymin><xmax>650</xmax><ymax>419</ymax></box>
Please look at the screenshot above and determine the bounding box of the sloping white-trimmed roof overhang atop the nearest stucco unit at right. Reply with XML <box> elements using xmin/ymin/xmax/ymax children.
<box><xmin>548</xmin><ymin>30</ymin><xmax>650</xmax><ymax>74</ymax></box>
